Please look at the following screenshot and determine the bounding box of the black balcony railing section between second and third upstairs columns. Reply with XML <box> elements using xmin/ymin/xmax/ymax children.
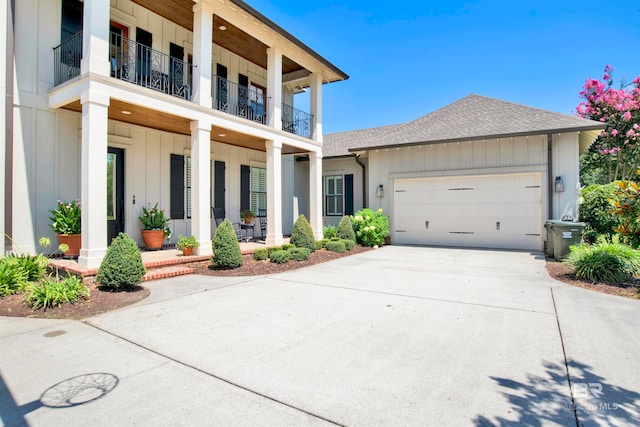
<box><xmin>211</xmin><ymin>74</ymin><xmax>268</xmax><ymax>124</ymax></box>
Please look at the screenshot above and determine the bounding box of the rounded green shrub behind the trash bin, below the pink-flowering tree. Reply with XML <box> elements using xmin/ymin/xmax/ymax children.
<box><xmin>578</xmin><ymin>183</ymin><xmax>618</xmax><ymax>237</ymax></box>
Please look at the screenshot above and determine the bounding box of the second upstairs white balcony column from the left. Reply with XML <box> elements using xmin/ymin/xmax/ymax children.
<box><xmin>193</xmin><ymin>0</ymin><xmax>213</xmax><ymax>108</ymax></box>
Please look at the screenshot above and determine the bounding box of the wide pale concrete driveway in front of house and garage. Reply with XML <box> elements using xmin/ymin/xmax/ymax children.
<box><xmin>0</xmin><ymin>246</ymin><xmax>640</xmax><ymax>426</ymax></box>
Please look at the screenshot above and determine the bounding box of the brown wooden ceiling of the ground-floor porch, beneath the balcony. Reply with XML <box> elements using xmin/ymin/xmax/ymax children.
<box><xmin>62</xmin><ymin>99</ymin><xmax>304</xmax><ymax>154</ymax></box>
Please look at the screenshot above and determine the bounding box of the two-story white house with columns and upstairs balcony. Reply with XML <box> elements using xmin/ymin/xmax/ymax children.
<box><xmin>0</xmin><ymin>0</ymin><xmax>348</xmax><ymax>268</ymax></box>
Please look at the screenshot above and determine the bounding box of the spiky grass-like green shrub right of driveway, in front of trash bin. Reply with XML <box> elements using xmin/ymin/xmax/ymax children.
<box><xmin>563</xmin><ymin>240</ymin><xmax>640</xmax><ymax>283</ymax></box>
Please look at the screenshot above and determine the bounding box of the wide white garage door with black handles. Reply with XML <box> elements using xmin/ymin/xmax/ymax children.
<box><xmin>393</xmin><ymin>173</ymin><xmax>542</xmax><ymax>250</ymax></box>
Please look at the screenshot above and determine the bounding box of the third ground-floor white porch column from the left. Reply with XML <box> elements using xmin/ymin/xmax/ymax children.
<box><xmin>265</xmin><ymin>141</ymin><xmax>283</xmax><ymax>246</ymax></box>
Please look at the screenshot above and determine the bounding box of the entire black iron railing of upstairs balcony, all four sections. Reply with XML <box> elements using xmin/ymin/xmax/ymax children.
<box><xmin>53</xmin><ymin>32</ymin><xmax>313</xmax><ymax>138</ymax></box>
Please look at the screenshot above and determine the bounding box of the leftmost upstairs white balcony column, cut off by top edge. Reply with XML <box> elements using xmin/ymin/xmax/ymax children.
<box><xmin>80</xmin><ymin>0</ymin><xmax>111</xmax><ymax>76</ymax></box>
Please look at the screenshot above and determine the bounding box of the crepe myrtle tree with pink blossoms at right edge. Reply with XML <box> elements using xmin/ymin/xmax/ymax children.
<box><xmin>576</xmin><ymin>65</ymin><xmax>640</xmax><ymax>184</ymax></box>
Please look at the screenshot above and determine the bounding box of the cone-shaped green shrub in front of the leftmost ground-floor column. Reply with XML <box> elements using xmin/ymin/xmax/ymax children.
<box><xmin>96</xmin><ymin>233</ymin><xmax>147</xmax><ymax>290</ymax></box>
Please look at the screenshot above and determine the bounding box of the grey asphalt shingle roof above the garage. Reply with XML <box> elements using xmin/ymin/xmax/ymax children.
<box><xmin>323</xmin><ymin>95</ymin><xmax>605</xmax><ymax>157</ymax></box>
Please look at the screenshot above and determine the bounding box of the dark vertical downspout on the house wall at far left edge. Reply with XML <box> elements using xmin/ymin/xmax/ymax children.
<box><xmin>3</xmin><ymin>0</ymin><xmax>15</xmax><ymax>253</ymax></box>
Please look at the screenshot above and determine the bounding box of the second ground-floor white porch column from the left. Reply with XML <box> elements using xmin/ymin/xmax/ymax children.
<box><xmin>191</xmin><ymin>120</ymin><xmax>213</xmax><ymax>255</ymax></box>
